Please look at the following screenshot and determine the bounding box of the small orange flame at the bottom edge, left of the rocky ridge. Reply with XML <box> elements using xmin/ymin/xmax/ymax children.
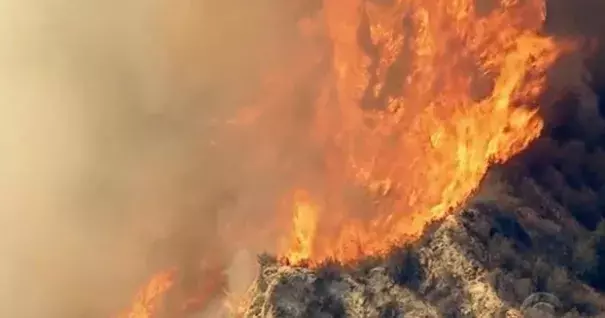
<box><xmin>118</xmin><ymin>270</ymin><xmax>175</xmax><ymax>318</ymax></box>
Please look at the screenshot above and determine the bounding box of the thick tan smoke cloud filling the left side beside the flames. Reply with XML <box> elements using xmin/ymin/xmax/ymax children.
<box><xmin>0</xmin><ymin>0</ymin><xmax>300</xmax><ymax>318</ymax></box>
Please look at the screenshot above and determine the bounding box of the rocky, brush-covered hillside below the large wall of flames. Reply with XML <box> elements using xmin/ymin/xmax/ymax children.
<box><xmin>237</xmin><ymin>168</ymin><xmax>605</xmax><ymax>317</ymax></box>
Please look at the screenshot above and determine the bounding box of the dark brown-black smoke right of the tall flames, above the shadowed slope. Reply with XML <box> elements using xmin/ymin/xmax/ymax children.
<box><xmin>510</xmin><ymin>0</ymin><xmax>605</xmax><ymax>230</ymax></box>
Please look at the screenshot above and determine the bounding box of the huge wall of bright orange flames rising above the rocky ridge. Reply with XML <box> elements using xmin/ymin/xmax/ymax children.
<box><xmin>285</xmin><ymin>0</ymin><xmax>568</xmax><ymax>264</ymax></box>
